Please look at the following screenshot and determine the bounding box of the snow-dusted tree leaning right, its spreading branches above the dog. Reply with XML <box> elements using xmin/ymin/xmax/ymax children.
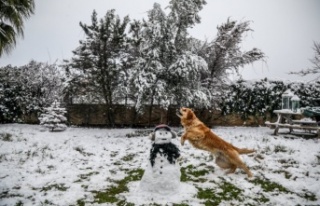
<box><xmin>188</xmin><ymin>19</ymin><xmax>265</xmax><ymax>106</ymax></box>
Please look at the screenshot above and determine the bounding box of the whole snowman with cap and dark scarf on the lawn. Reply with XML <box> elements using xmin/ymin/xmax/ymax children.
<box><xmin>140</xmin><ymin>124</ymin><xmax>181</xmax><ymax>195</ymax></box>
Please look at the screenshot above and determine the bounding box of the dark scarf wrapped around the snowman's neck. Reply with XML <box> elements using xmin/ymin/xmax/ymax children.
<box><xmin>150</xmin><ymin>142</ymin><xmax>180</xmax><ymax>167</ymax></box>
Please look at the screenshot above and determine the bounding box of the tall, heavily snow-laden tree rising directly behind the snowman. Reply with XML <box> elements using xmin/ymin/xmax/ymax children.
<box><xmin>129</xmin><ymin>0</ymin><xmax>208</xmax><ymax>114</ymax></box>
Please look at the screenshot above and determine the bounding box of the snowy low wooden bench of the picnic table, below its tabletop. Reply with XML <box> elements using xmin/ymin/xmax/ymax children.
<box><xmin>265</xmin><ymin>120</ymin><xmax>320</xmax><ymax>138</ymax></box>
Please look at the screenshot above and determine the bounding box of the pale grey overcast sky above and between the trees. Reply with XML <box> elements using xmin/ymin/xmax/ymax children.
<box><xmin>0</xmin><ymin>0</ymin><xmax>320</xmax><ymax>80</ymax></box>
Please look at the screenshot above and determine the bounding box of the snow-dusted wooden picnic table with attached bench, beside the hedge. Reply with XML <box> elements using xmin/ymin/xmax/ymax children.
<box><xmin>265</xmin><ymin>109</ymin><xmax>320</xmax><ymax>137</ymax></box>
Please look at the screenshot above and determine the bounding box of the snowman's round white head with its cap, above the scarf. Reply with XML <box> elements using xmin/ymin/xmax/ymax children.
<box><xmin>150</xmin><ymin>124</ymin><xmax>176</xmax><ymax>144</ymax></box>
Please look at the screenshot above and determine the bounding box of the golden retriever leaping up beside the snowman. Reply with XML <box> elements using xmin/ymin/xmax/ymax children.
<box><xmin>177</xmin><ymin>107</ymin><xmax>255</xmax><ymax>177</ymax></box>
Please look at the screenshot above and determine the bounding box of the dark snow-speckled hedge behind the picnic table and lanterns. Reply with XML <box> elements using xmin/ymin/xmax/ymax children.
<box><xmin>220</xmin><ymin>79</ymin><xmax>320</xmax><ymax>119</ymax></box>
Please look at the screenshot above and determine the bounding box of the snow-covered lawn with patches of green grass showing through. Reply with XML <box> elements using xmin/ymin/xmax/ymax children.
<box><xmin>0</xmin><ymin>124</ymin><xmax>320</xmax><ymax>205</ymax></box>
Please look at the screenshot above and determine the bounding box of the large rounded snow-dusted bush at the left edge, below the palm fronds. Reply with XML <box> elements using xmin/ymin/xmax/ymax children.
<box><xmin>0</xmin><ymin>61</ymin><xmax>65</xmax><ymax>122</ymax></box>
